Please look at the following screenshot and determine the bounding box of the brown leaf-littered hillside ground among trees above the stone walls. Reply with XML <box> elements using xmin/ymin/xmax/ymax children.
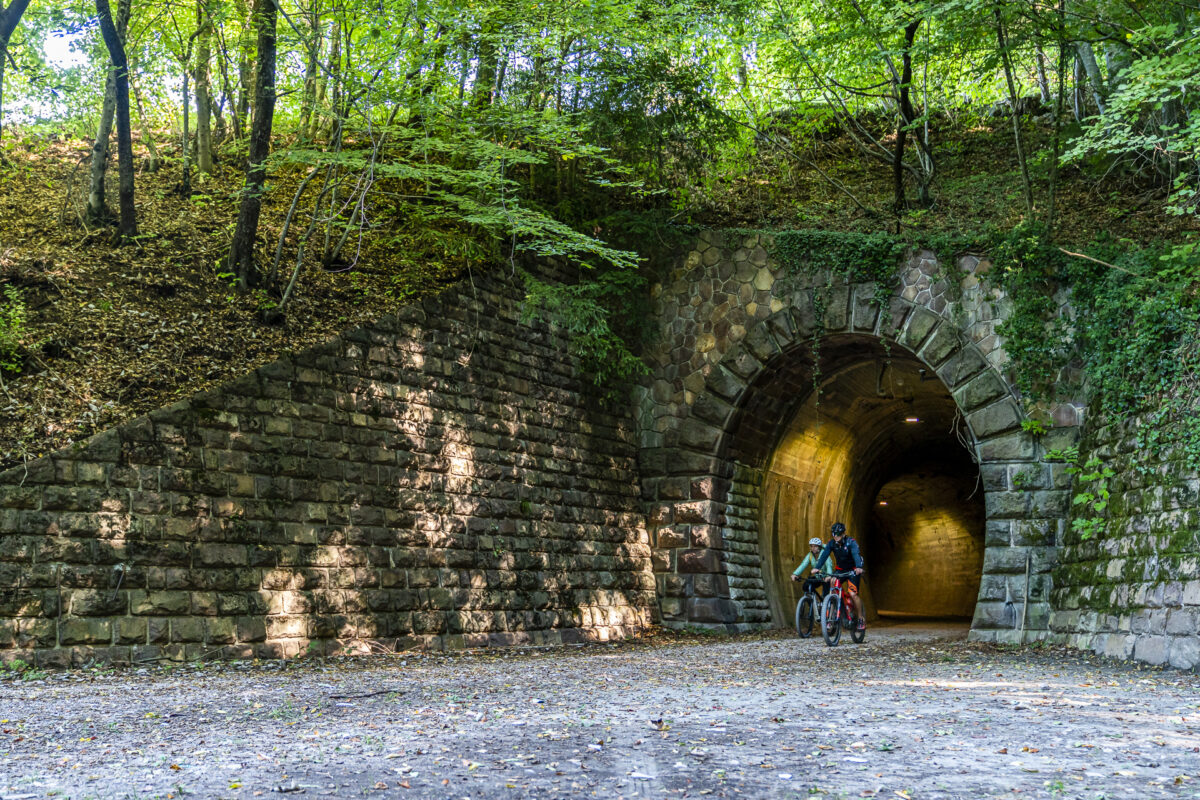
<box><xmin>0</xmin><ymin>119</ymin><xmax>1194</xmax><ymax>465</ymax></box>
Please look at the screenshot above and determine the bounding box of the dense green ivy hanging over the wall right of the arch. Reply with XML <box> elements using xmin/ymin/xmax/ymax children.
<box><xmin>992</xmin><ymin>225</ymin><xmax>1200</xmax><ymax>469</ymax></box>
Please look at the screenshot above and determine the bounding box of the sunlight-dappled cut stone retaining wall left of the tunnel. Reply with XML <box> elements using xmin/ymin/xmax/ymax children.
<box><xmin>0</xmin><ymin>268</ymin><xmax>658</xmax><ymax>666</ymax></box>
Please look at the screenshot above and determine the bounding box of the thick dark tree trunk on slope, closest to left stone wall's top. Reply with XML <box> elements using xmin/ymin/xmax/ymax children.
<box><xmin>229</xmin><ymin>0</ymin><xmax>275</xmax><ymax>290</ymax></box>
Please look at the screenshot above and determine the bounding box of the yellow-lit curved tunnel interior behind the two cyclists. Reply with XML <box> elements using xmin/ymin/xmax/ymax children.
<box><xmin>732</xmin><ymin>336</ymin><xmax>985</xmax><ymax>625</ymax></box>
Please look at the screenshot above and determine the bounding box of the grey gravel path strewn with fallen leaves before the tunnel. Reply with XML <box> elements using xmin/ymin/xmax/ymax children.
<box><xmin>0</xmin><ymin>625</ymin><xmax>1200</xmax><ymax>800</ymax></box>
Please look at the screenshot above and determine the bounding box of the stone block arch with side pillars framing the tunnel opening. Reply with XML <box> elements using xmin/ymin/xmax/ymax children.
<box><xmin>648</xmin><ymin>283</ymin><xmax>1068</xmax><ymax>639</ymax></box>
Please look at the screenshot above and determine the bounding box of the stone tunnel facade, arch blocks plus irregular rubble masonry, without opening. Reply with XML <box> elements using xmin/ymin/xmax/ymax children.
<box><xmin>638</xmin><ymin>234</ymin><xmax>1080</xmax><ymax>642</ymax></box>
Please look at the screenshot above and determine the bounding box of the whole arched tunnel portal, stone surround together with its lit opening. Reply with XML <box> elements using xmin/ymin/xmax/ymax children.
<box><xmin>641</xmin><ymin>291</ymin><xmax>1069</xmax><ymax>640</ymax></box>
